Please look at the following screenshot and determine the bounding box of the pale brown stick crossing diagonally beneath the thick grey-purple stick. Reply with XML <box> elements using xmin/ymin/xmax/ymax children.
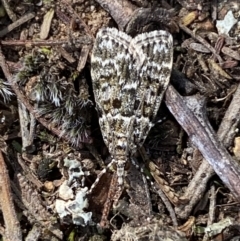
<box><xmin>175</xmin><ymin>85</ymin><xmax>240</xmax><ymax>219</ymax></box>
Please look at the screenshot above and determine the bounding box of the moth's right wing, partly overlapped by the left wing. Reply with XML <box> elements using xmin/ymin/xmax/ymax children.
<box><xmin>131</xmin><ymin>30</ymin><xmax>173</xmax><ymax>146</ymax></box>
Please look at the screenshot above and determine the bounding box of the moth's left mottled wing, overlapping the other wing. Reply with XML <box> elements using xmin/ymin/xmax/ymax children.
<box><xmin>91</xmin><ymin>28</ymin><xmax>146</xmax><ymax>158</ymax></box>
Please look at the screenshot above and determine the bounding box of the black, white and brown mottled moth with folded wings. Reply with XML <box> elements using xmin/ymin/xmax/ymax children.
<box><xmin>91</xmin><ymin>28</ymin><xmax>173</xmax><ymax>185</ymax></box>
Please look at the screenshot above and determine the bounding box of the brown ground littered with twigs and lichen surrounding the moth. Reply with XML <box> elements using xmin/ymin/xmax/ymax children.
<box><xmin>0</xmin><ymin>0</ymin><xmax>240</xmax><ymax>241</ymax></box>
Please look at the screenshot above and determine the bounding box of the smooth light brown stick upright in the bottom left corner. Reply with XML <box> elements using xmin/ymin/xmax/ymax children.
<box><xmin>0</xmin><ymin>150</ymin><xmax>22</xmax><ymax>241</ymax></box>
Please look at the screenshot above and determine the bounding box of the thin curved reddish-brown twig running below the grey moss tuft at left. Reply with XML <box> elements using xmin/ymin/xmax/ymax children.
<box><xmin>0</xmin><ymin>48</ymin><xmax>86</xmax><ymax>146</ymax></box>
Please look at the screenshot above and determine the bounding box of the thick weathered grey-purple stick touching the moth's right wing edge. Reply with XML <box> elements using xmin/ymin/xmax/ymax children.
<box><xmin>165</xmin><ymin>85</ymin><xmax>240</xmax><ymax>201</ymax></box>
